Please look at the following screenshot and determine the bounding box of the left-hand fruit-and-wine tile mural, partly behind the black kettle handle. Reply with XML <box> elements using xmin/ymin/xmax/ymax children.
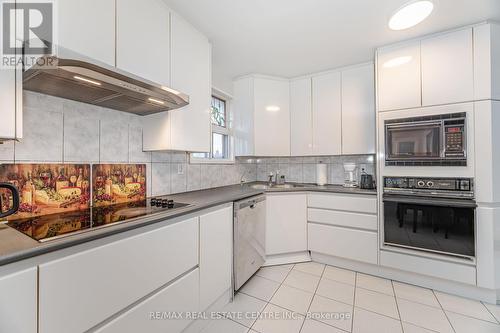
<box><xmin>0</xmin><ymin>164</ymin><xmax>90</xmax><ymax>220</ymax></box>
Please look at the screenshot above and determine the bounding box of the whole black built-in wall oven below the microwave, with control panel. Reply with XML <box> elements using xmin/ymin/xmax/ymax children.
<box><xmin>383</xmin><ymin>177</ymin><xmax>476</xmax><ymax>260</ymax></box>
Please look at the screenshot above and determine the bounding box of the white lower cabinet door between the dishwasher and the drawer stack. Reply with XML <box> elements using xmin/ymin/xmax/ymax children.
<box><xmin>266</xmin><ymin>194</ymin><xmax>307</xmax><ymax>255</ymax></box>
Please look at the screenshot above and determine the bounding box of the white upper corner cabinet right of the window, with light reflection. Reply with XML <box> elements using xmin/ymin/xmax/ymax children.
<box><xmin>233</xmin><ymin>76</ymin><xmax>290</xmax><ymax>156</ymax></box>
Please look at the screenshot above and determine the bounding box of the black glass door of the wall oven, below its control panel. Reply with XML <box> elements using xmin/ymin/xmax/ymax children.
<box><xmin>384</xmin><ymin>194</ymin><xmax>476</xmax><ymax>259</ymax></box>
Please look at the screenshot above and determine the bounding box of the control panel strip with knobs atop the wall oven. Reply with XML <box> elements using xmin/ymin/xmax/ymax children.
<box><xmin>384</xmin><ymin>177</ymin><xmax>473</xmax><ymax>192</ymax></box>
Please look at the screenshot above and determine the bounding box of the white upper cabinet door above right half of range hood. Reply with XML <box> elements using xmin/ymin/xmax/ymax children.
<box><xmin>116</xmin><ymin>0</ymin><xmax>170</xmax><ymax>86</ymax></box>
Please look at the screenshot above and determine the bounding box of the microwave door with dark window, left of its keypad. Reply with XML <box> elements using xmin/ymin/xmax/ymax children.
<box><xmin>385</xmin><ymin>121</ymin><xmax>443</xmax><ymax>161</ymax></box>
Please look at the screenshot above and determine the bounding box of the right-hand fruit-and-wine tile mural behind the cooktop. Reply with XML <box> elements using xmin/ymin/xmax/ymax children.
<box><xmin>92</xmin><ymin>164</ymin><xmax>146</xmax><ymax>207</ymax></box>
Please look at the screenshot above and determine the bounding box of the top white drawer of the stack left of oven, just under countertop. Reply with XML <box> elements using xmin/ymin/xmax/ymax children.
<box><xmin>307</xmin><ymin>193</ymin><xmax>377</xmax><ymax>214</ymax></box>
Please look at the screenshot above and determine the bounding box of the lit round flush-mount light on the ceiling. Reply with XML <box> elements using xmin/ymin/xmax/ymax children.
<box><xmin>389</xmin><ymin>0</ymin><xmax>434</xmax><ymax>30</ymax></box>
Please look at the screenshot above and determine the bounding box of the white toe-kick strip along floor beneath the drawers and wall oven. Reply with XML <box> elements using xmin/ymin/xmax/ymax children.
<box><xmin>311</xmin><ymin>252</ymin><xmax>498</xmax><ymax>304</ymax></box>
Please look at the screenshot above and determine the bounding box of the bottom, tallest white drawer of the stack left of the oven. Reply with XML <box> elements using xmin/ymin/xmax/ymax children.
<box><xmin>308</xmin><ymin>223</ymin><xmax>378</xmax><ymax>264</ymax></box>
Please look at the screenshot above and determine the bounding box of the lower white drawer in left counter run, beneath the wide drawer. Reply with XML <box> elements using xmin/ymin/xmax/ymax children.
<box><xmin>96</xmin><ymin>269</ymin><xmax>200</xmax><ymax>333</ymax></box>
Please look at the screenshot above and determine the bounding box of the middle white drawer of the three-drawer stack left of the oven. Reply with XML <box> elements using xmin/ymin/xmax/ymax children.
<box><xmin>307</xmin><ymin>208</ymin><xmax>377</xmax><ymax>231</ymax></box>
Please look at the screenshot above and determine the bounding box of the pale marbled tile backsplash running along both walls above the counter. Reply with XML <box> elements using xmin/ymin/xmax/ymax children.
<box><xmin>0</xmin><ymin>92</ymin><xmax>375</xmax><ymax>196</ymax></box>
